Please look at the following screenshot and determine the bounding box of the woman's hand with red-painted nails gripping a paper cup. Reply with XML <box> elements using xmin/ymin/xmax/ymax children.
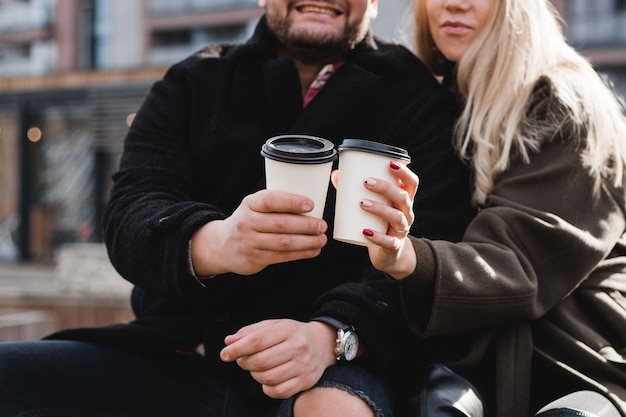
<box><xmin>331</xmin><ymin>161</ymin><xmax>419</xmax><ymax>279</ymax></box>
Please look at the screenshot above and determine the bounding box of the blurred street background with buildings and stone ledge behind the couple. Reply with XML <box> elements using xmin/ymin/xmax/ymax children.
<box><xmin>0</xmin><ymin>0</ymin><xmax>626</xmax><ymax>340</ymax></box>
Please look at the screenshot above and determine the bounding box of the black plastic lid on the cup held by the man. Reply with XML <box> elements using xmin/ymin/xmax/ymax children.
<box><xmin>261</xmin><ymin>135</ymin><xmax>337</xmax><ymax>164</ymax></box>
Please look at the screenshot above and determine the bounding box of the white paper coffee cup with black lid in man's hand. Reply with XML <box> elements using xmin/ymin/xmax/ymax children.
<box><xmin>261</xmin><ymin>135</ymin><xmax>337</xmax><ymax>218</ymax></box>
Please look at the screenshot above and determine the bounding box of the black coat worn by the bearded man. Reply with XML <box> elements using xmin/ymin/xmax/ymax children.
<box><xmin>48</xmin><ymin>16</ymin><xmax>473</xmax><ymax>398</ymax></box>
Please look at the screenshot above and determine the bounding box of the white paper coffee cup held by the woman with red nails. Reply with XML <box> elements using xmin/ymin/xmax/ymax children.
<box><xmin>333</xmin><ymin>139</ymin><xmax>411</xmax><ymax>246</ymax></box>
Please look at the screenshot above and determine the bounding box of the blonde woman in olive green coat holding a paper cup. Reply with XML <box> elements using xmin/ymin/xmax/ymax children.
<box><xmin>354</xmin><ymin>0</ymin><xmax>626</xmax><ymax>417</ymax></box>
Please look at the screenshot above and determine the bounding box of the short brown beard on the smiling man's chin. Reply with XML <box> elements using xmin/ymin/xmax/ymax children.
<box><xmin>268</xmin><ymin>17</ymin><xmax>364</xmax><ymax>64</ymax></box>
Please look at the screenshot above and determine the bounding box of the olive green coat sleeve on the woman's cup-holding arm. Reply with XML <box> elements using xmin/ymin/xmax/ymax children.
<box><xmin>400</xmin><ymin>111</ymin><xmax>625</xmax><ymax>337</ymax></box>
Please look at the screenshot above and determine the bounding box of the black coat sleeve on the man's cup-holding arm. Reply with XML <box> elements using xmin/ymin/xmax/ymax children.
<box><xmin>104</xmin><ymin>58</ymin><xmax>224</xmax><ymax>296</ymax></box>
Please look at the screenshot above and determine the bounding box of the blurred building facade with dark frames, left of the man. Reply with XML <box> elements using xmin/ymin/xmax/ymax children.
<box><xmin>0</xmin><ymin>0</ymin><xmax>261</xmax><ymax>261</ymax></box>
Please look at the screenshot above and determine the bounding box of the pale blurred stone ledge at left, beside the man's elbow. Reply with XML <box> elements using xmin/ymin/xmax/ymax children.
<box><xmin>0</xmin><ymin>240</ymin><xmax>134</xmax><ymax>341</ymax></box>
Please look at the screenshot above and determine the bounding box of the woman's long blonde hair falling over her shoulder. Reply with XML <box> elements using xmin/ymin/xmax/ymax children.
<box><xmin>413</xmin><ymin>0</ymin><xmax>626</xmax><ymax>204</ymax></box>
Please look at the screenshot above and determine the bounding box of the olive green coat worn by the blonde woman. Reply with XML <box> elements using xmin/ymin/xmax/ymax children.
<box><xmin>400</xmin><ymin>80</ymin><xmax>626</xmax><ymax>417</ymax></box>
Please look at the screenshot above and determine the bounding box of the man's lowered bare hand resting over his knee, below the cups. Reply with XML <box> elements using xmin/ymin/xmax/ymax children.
<box><xmin>220</xmin><ymin>319</ymin><xmax>337</xmax><ymax>399</ymax></box>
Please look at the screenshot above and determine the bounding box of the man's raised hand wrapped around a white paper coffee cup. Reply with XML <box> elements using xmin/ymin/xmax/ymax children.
<box><xmin>191</xmin><ymin>190</ymin><xmax>328</xmax><ymax>275</ymax></box>
